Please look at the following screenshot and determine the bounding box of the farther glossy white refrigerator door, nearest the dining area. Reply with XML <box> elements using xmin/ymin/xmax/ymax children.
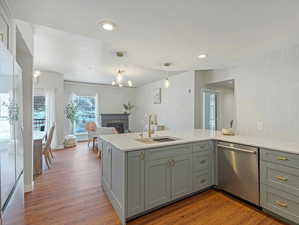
<box><xmin>14</xmin><ymin>62</ymin><xmax>24</xmax><ymax>179</ymax></box>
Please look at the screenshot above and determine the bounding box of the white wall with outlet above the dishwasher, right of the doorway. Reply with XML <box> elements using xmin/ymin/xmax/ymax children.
<box><xmin>205</xmin><ymin>45</ymin><xmax>299</xmax><ymax>141</ymax></box>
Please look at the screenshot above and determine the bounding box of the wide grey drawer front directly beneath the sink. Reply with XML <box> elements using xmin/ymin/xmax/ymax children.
<box><xmin>145</xmin><ymin>144</ymin><xmax>192</xmax><ymax>160</ymax></box>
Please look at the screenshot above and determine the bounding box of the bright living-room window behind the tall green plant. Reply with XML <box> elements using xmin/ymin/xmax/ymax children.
<box><xmin>75</xmin><ymin>96</ymin><xmax>96</xmax><ymax>134</ymax></box>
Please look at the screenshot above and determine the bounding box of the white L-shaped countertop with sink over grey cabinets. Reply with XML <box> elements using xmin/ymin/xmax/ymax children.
<box><xmin>100</xmin><ymin>129</ymin><xmax>299</xmax><ymax>154</ymax></box>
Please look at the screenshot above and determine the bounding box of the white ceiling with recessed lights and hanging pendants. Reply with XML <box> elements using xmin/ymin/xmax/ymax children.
<box><xmin>8</xmin><ymin>0</ymin><xmax>299</xmax><ymax>85</ymax></box>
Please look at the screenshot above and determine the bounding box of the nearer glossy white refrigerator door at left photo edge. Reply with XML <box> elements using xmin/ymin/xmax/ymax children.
<box><xmin>0</xmin><ymin>43</ymin><xmax>16</xmax><ymax>207</ymax></box>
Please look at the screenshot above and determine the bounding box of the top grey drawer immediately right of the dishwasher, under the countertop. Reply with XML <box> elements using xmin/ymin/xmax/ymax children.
<box><xmin>260</xmin><ymin>149</ymin><xmax>299</xmax><ymax>169</ymax></box>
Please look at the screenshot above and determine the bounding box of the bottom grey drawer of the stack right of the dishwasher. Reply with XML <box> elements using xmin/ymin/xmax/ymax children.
<box><xmin>261</xmin><ymin>185</ymin><xmax>299</xmax><ymax>223</ymax></box>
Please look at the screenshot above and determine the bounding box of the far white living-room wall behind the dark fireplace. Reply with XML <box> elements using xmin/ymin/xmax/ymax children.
<box><xmin>64</xmin><ymin>81</ymin><xmax>136</xmax><ymax>134</ymax></box>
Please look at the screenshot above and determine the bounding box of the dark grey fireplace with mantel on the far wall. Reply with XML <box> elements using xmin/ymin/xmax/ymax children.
<box><xmin>101</xmin><ymin>113</ymin><xmax>129</xmax><ymax>133</ymax></box>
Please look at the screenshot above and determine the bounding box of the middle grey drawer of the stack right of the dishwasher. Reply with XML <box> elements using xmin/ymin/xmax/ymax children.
<box><xmin>261</xmin><ymin>161</ymin><xmax>299</xmax><ymax>197</ymax></box>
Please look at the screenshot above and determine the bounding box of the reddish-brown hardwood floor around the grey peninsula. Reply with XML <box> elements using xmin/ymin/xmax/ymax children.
<box><xmin>16</xmin><ymin>143</ymin><xmax>284</xmax><ymax>225</ymax></box>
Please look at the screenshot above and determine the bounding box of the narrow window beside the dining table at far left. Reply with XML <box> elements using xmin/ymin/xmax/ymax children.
<box><xmin>33</xmin><ymin>96</ymin><xmax>46</xmax><ymax>131</ymax></box>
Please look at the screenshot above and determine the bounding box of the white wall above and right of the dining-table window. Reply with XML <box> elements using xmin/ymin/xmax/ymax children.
<box><xmin>34</xmin><ymin>71</ymin><xmax>64</xmax><ymax>149</ymax></box>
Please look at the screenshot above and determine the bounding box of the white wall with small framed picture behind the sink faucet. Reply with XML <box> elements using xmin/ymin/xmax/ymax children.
<box><xmin>135</xmin><ymin>71</ymin><xmax>195</xmax><ymax>131</ymax></box>
